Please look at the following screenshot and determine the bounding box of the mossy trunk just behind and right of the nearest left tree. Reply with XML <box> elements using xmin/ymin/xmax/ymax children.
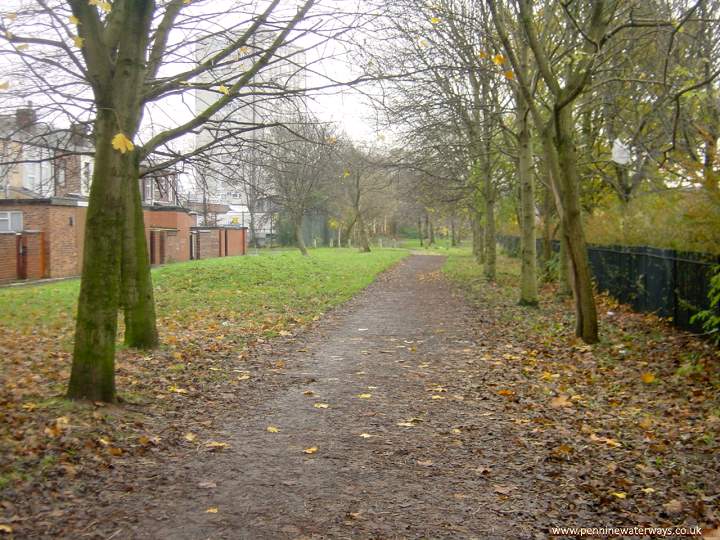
<box><xmin>122</xmin><ymin>158</ymin><xmax>159</xmax><ymax>349</ymax></box>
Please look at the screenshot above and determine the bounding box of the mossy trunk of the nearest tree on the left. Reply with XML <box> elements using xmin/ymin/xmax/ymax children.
<box><xmin>67</xmin><ymin>108</ymin><xmax>124</xmax><ymax>402</ymax></box>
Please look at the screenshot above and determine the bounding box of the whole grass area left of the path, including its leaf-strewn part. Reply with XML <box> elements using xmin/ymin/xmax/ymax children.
<box><xmin>0</xmin><ymin>249</ymin><xmax>408</xmax><ymax>498</ymax></box>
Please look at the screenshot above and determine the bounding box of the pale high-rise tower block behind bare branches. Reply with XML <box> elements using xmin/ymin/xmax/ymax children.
<box><xmin>188</xmin><ymin>38</ymin><xmax>306</xmax><ymax>243</ymax></box>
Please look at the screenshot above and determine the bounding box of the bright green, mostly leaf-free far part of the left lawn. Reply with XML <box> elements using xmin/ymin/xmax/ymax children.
<box><xmin>0</xmin><ymin>249</ymin><xmax>406</xmax><ymax>337</ymax></box>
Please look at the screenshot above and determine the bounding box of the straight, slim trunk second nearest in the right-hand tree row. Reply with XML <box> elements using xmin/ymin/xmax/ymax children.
<box><xmin>516</xmin><ymin>82</ymin><xmax>538</xmax><ymax>306</ymax></box>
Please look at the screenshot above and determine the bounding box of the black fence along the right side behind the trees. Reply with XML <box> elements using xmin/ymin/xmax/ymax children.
<box><xmin>498</xmin><ymin>236</ymin><xmax>720</xmax><ymax>332</ymax></box>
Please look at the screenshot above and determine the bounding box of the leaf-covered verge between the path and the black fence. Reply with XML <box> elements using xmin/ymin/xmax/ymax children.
<box><xmin>443</xmin><ymin>251</ymin><xmax>720</xmax><ymax>527</ymax></box>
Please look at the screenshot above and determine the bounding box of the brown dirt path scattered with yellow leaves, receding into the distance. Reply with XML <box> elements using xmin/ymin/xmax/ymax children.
<box><xmin>115</xmin><ymin>255</ymin><xmax>544</xmax><ymax>539</ymax></box>
